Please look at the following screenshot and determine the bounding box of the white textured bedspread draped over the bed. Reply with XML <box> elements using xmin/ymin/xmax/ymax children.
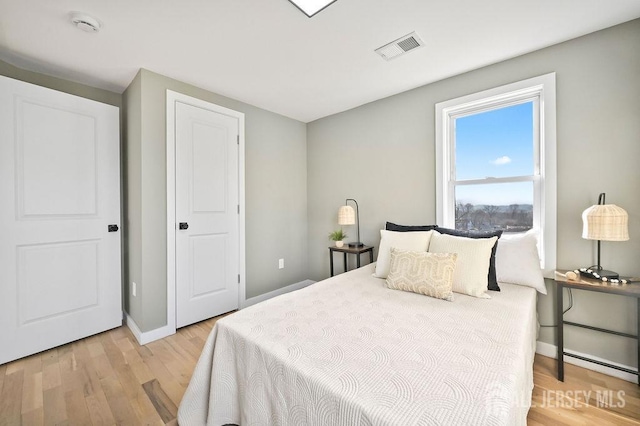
<box><xmin>178</xmin><ymin>265</ymin><xmax>537</xmax><ymax>426</ymax></box>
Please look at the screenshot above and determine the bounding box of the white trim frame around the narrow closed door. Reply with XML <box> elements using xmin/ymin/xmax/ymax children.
<box><xmin>166</xmin><ymin>89</ymin><xmax>246</xmax><ymax>334</ymax></box>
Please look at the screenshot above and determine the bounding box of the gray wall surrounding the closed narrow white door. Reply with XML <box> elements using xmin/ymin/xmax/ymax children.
<box><xmin>124</xmin><ymin>69</ymin><xmax>308</xmax><ymax>331</ymax></box>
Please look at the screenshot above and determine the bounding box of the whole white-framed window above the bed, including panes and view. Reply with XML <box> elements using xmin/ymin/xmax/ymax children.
<box><xmin>436</xmin><ymin>74</ymin><xmax>556</xmax><ymax>272</ymax></box>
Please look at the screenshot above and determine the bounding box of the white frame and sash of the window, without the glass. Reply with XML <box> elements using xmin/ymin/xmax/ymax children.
<box><xmin>435</xmin><ymin>73</ymin><xmax>557</xmax><ymax>277</ymax></box>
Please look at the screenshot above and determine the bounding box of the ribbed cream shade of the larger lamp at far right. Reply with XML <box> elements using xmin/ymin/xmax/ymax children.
<box><xmin>582</xmin><ymin>204</ymin><xmax>629</xmax><ymax>241</ymax></box>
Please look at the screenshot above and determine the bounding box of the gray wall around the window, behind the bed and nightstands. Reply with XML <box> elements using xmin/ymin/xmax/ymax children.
<box><xmin>307</xmin><ymin>20</ymin><xmax>640</xmax><ymax>366</ymax></box>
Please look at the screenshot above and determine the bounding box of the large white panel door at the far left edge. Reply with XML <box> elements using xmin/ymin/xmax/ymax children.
<box><xmin>0</xmin><ymin>77</ymin><xmax>122</xmax><ymax>364</ymax></box>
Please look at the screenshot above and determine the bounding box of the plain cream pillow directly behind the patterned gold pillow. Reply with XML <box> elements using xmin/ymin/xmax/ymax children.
<box><xmin>429</xmin><ymin>232</ymin><xmax>498</xmax><ymax>299</ymax></box>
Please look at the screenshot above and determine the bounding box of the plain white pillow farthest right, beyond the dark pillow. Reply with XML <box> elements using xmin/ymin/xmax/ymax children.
<box><xmin>496</xmin><ymin>232</ymin><xmax>547</xmax><ymax>294</ymax></box>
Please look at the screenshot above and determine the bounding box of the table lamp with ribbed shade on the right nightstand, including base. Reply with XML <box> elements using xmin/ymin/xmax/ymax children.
<box><xmin>580</xmin><ymin>192</ymin><xmax>629</xmax><ymax>281</ymax></box>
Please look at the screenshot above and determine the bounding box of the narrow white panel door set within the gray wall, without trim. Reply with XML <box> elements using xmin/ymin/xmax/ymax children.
<box><xmin>175</xmin><ymin>102</ymin><xmax>240</xmax><ymax>327</ymax></box>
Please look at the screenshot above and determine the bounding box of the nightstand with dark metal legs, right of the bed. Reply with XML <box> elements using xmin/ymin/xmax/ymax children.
<box><xmin>555</xmin><ymin>271</ymin><xmax>640</xmax><ymax>386</ymax></box>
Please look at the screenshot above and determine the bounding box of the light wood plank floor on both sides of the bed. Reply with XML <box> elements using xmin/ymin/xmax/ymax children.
<box><xmin>0</xmin><ymin>319</ymin><xmax>640</xmax><ymax>426</ymax></box>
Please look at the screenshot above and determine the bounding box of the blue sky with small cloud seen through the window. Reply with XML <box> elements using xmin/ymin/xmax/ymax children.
<box><xmin>455</xmin><ymin>102</ymin><xmax>534</xmax><ymax>205</ymax></box>
